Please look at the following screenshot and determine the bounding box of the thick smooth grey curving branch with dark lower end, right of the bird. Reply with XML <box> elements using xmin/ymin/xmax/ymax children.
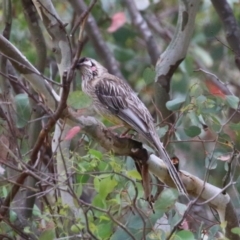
<box><xmin>155</xmin><ymin>0</ymin><xmax>200</xmax><ymax>123</ymax></box>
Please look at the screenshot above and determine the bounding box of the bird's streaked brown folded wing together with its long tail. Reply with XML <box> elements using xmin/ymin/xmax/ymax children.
<box><xmin>95</xmin><ymin>77</ymin><xmax>186</xmax><ymax>194</ymax></box>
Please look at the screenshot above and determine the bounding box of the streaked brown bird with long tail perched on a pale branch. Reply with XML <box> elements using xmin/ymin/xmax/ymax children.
<box><xmin>76</xmin><ymin>57</ymin><xmax>187</xmax><ymax>195</ymax></box>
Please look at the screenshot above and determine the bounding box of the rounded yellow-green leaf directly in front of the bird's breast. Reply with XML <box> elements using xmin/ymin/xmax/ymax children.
<box><xmin>67</xmin><ymin>91</ymin><xmax>92</xmax><ymax>109</ymax></box>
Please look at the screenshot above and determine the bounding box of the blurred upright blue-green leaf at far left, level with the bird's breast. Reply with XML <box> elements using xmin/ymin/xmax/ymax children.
<box><xmin>14</xmin><ymin>93</ymin><xmax>31</xmax><ymax>128</ymax></box>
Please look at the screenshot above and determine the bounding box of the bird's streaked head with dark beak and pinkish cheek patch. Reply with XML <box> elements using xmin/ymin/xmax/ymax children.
<box><xmin>77</xmin><ymin>57</ymin><xmax>107</xmax><ymax>80</ymax></box>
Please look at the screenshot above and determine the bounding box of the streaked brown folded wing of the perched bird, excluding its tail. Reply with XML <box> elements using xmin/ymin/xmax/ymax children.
<box><xmin>95</xmin><ymin>77</ymin><xmax>152</xmax><ymax>134</ymax></box>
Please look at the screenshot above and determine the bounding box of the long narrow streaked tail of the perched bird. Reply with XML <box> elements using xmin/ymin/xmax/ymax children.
<box><xmin>147</xmin><ymin>131</ymin><xmax>188</xmax><ymax>195</ymax></box>
